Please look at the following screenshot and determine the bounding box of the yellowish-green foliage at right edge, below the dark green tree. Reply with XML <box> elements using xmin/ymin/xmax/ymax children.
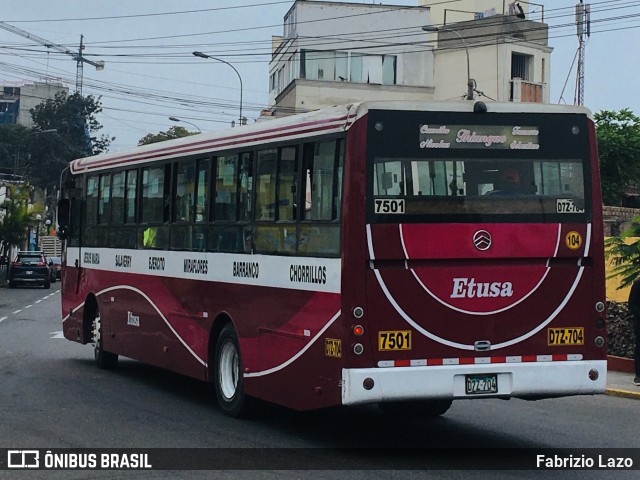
<box><xmin>604</xmin><ymin>217</ymin><xmax>640</xmax><ymax>289</ymax></box>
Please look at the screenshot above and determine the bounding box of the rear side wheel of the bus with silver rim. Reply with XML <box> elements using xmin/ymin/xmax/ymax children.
<box><xmin>213</xmin><ymin>323</ymin><xmax>247</xmax><ymax>418</ymax></box>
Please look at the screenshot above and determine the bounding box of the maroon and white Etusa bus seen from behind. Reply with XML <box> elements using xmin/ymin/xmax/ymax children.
<box><xmin>59</xmin><ymin>101</ymin><xmax>607</xmax><ymax>416</ymax></box>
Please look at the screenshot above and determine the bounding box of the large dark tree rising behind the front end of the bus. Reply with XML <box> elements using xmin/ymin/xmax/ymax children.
<box><xmin>28</xmin><ymin>92</ymin><xmax>114</xmax><ymax>190</ymax></box>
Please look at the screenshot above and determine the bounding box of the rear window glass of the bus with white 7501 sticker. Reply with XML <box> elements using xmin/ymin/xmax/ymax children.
<box><xmin>370</xmin><ymin>158</ymin><xmax>585</xmax><ymax>221</ymax></box>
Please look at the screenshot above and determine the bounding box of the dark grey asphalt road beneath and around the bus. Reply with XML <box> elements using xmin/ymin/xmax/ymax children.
<box><xmin>0</xmin><ymin>283</ymin><xmax>640</xmax><ymax>480</ymax></box>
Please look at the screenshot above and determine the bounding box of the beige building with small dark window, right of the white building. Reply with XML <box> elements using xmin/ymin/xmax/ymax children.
<box><xmin>420</xmin><ymin>0</ymin><xmax>553</xmax><ymax>103</ymax></box>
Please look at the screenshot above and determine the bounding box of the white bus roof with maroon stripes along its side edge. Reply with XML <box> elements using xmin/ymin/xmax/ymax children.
<box><xmin>70</xmin><ymin>100</ymin><xmax>591</xmax><ymax>174</ymax></box>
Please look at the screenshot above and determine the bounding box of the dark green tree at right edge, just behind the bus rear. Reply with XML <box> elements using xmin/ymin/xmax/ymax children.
<box><xmin>594</xmin><ymin>108</ymin><xmax>640</xmax><ymax>205</ymax></box>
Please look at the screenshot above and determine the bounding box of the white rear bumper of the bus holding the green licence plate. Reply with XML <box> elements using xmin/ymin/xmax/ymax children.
<box><xmin>342</xmin><ymin>360</ymin><xmax>607</xmax><ymax>405</ymax></box>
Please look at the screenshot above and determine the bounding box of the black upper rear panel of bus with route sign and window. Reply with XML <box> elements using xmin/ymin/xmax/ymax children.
<box><xmin>367</xmin><ymin>111</ymin><xmax>591</xmax><ymax>223</ymax></box>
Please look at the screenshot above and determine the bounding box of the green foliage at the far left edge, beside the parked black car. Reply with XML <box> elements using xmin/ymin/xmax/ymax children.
<box><xmin>0</xmin><ymin>185</ymin><xmax>31</xmax><ymax>257</ymax></box>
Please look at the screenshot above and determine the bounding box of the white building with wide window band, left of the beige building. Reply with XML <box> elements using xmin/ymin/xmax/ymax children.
<box><xmin>269</xmin><ymin>0</ymin><xmax>435</xmax><ymax>116</ymax></box>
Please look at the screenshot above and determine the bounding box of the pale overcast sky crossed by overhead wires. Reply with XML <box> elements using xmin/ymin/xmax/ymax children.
<box><xmin>0</xmin><ymin>0</ymin><xmax>640</xmax><ymax>150</ymax></box>
